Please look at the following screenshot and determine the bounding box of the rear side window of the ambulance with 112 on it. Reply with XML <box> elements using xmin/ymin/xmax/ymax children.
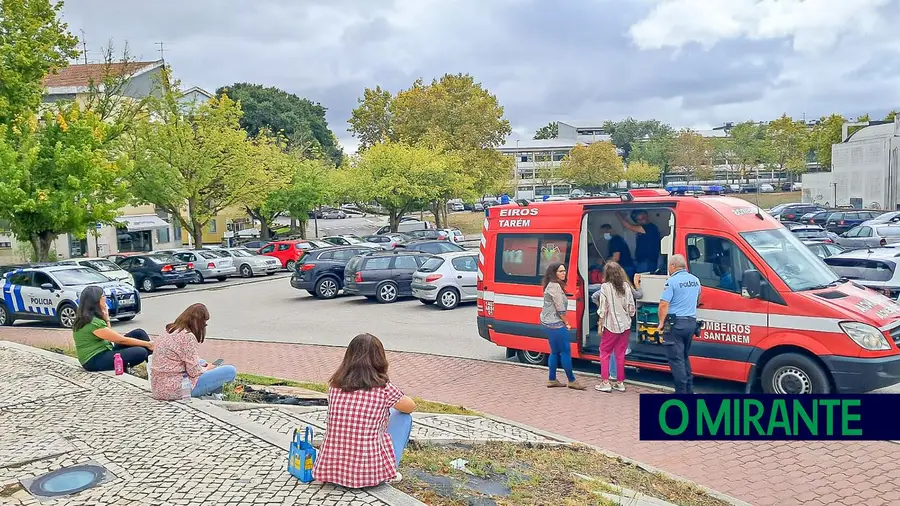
<box><xmin>494</xmin><ymin>234</ymin><xmax>572</xmax><ymax>285</ymax></box>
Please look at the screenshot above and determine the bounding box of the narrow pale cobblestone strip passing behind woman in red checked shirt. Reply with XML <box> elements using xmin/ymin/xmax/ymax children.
<box><xmin>226</xmin><ymin>403</ymin><xmax>565</xmax><ymax>444</ymax></box>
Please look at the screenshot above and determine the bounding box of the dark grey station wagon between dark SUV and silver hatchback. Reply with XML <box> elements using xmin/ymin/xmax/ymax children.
<box><xmin>344</xmin><ymin>249</ymin><xmax>431</xmax><ymax>304</ymax></box>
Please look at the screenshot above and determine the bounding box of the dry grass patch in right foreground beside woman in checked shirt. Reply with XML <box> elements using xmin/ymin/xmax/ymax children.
<box><xmin>394</xmin><ymin>442</ymin><xmax>727</xmax><ymax>506</ymax></box>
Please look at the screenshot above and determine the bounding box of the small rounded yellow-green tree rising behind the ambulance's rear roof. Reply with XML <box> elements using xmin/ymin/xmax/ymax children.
<box><xmin>560</xmin><ymin>142</ymin><xmax>625</xmax><ymax>189</ymax></box>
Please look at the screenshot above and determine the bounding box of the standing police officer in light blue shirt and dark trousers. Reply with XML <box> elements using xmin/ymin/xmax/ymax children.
<box><xmin>659</xmin><ymin>255</ymin><xmax>700</xmax><ymax>394</ymax></box>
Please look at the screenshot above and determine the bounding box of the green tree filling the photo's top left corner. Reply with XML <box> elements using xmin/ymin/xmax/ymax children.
<box><xmin>0</xmin><ymin>0</ymin><xmax>78</xmax><ymax>128</ymax></box>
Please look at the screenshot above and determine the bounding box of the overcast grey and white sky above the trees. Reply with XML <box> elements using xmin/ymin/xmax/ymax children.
<box><xmin>64</xmin><ymin>0</ymin><xmax>900</xmax><ymax>151</ymax></box>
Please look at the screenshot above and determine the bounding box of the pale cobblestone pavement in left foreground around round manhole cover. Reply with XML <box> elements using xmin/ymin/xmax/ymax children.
<box><xmin>0</xmin><ymin>336</ymin><xmax>421</xmax><ymax>506</ymax></box>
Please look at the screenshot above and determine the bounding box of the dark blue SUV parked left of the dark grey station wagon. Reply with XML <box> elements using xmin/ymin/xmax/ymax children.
<box><xmin>291</xmin><ymin>246</ymin><xmax>375</xmax><ymax>299</ymax></box>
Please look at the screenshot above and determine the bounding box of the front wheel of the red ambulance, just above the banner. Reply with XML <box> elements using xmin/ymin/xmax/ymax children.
<box><xmin>762</xmin><ymin>353</ymin><xmax>831</xmax><ymax>395</ymax></box>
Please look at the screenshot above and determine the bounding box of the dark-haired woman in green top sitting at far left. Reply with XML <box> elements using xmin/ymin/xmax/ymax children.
<box><xmin>73</xmin><ymin>286</ymin><xmax>153</xmax><ymax>372</ymax></box>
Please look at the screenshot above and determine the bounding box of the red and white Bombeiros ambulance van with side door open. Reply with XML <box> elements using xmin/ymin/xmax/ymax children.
<box><xmin>477</xmin><ymin>189</ymin><xmax>900</xmax><ymax>394</ymax></box>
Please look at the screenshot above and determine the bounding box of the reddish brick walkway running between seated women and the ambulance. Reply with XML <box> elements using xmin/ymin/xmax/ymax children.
<box><xmin>7</xmin><ymin>328</ymin><xmax>900</xmax><ymax>506</ymax></box>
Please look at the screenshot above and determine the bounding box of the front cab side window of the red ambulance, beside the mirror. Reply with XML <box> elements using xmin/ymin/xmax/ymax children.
<box><xmin>687</xmin><ymin>235</ymin><xmax>754</xmax><ymax>293</ymax></box>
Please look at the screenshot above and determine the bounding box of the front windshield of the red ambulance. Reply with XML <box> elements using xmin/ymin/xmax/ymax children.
<box><xmin>741</xmin><ymin>227</ymin><xmax>840</xmax><ymax>292</ymax></box>
